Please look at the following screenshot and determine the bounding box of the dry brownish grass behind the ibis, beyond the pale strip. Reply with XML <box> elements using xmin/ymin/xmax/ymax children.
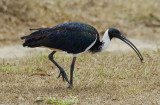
<box><xmin>0</xmin><ymin>0</ymin><xmax>160</xmax><ymax>46</ymax></box>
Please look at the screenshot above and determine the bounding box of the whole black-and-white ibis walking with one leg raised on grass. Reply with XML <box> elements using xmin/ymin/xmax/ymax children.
<box><xmin>21</xmin><ymin>22</ymin><xmax>143</xmax><ymax>88</ymax></box>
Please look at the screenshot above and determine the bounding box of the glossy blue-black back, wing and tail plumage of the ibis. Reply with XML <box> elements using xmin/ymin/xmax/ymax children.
<box><xmin>21</xmin><ymin>22</ymin><xmax>100</xmax><ymax>54</ymax></box>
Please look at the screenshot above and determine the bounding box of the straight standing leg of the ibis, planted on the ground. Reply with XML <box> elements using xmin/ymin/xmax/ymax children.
<box><xmin>69</xmin><ymin>57</ymin><xmax>77</xmax><ymax>88</ymax></box>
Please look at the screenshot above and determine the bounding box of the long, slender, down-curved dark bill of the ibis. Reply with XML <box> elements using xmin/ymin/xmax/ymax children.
<box><xmin>116</xmin><ymin>35</ymin><xmax>143</xmax><ymax>62</ymax></box>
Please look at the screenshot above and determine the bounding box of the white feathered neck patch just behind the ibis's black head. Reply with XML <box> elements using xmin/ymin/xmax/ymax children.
<box><xmin>101</xmin><ymin>30</ymin><xmax>111</xmax><ymax>51</ymax></box>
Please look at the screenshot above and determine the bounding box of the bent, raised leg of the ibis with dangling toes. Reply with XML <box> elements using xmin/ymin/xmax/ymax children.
<box><xmin>48</xmin><ymin>51</ymin><xmax>69</xmax><ymax>83</ymax></box>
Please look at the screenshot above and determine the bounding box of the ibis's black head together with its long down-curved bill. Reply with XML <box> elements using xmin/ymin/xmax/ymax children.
<box><xmin>105</xmin><ymin>28</ymin><xmax>143</xmax><ymax>62</ymax></box>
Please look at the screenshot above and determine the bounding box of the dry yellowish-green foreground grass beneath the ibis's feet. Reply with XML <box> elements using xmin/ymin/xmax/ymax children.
<box><xmin>0</xmin><ymin>51</ymin><xmax>160</xmax><ymax>105</ymax></box>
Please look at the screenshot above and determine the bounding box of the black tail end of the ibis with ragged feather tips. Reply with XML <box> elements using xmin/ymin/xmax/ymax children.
<box><xmin>21</xmin><ymin>28</ymin><xmax>48</xmax><ymax>47</ymax></box>
